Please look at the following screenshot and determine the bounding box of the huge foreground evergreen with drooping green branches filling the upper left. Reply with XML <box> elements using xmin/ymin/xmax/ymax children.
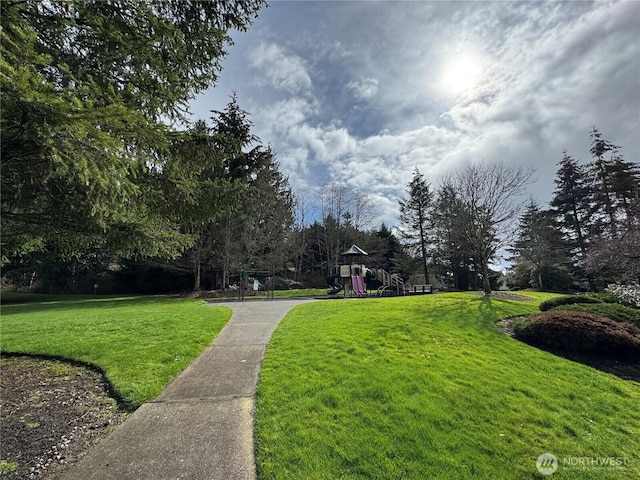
<box><xmin>0</xmin><ymin>0</ymin><xmax>263</xmax><ymax>257</ymax></box>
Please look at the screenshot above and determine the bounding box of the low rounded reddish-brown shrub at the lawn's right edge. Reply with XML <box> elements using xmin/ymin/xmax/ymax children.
<box><xmin>513</xmin><ymin>310</ymin><xmax>640</xmax><ymax>360</ymax></box>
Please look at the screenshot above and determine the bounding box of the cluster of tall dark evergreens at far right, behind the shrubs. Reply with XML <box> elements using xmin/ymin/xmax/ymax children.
<box><xmin>511</xmin><ymin>127</ymin><xmax>640</xmax><ymax>291</ymax></box>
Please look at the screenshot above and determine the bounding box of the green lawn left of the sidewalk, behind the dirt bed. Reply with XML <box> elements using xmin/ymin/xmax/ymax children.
<box><xmin>0</xmin><ymin>296</ymin><xmax>231</xmax><ymax>408</ymax></box>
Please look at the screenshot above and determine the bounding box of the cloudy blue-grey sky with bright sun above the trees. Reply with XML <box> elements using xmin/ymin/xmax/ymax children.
<box><xmin>190</xmin><ymin>0</ymin><xmax>640</xmax><ymax>228</ymax></box>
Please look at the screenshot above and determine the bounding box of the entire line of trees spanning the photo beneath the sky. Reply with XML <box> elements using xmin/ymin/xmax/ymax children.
<box><xmin>0</xmin><ymin>0</ymin><xmax>640</xmax><ymax>293</ymax></box>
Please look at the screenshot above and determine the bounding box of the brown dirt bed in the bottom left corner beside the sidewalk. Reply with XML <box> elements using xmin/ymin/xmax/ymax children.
<box><xmin>0</xmin><ymin>356</ymin><xmax>128</xmax><ymax>479</ymax></box>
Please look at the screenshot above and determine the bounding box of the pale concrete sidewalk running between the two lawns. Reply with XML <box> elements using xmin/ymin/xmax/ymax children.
<box><xmin>61</xmin><ymin>300</ymin><xmax>309</xmax><ymax>480</ymax></box>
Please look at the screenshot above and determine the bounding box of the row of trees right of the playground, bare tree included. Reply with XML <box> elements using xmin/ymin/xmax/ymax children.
<box><xmin>400</xmin><ymin>127</ymin><xmax>640</xmax><ymax>293</ymax></box>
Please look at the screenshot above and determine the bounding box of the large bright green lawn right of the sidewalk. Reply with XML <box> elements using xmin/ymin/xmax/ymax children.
<box><xmin>256</xmin><ymin>294</ymin><xmax>640</xmax><ymax>480</ymax></box>
